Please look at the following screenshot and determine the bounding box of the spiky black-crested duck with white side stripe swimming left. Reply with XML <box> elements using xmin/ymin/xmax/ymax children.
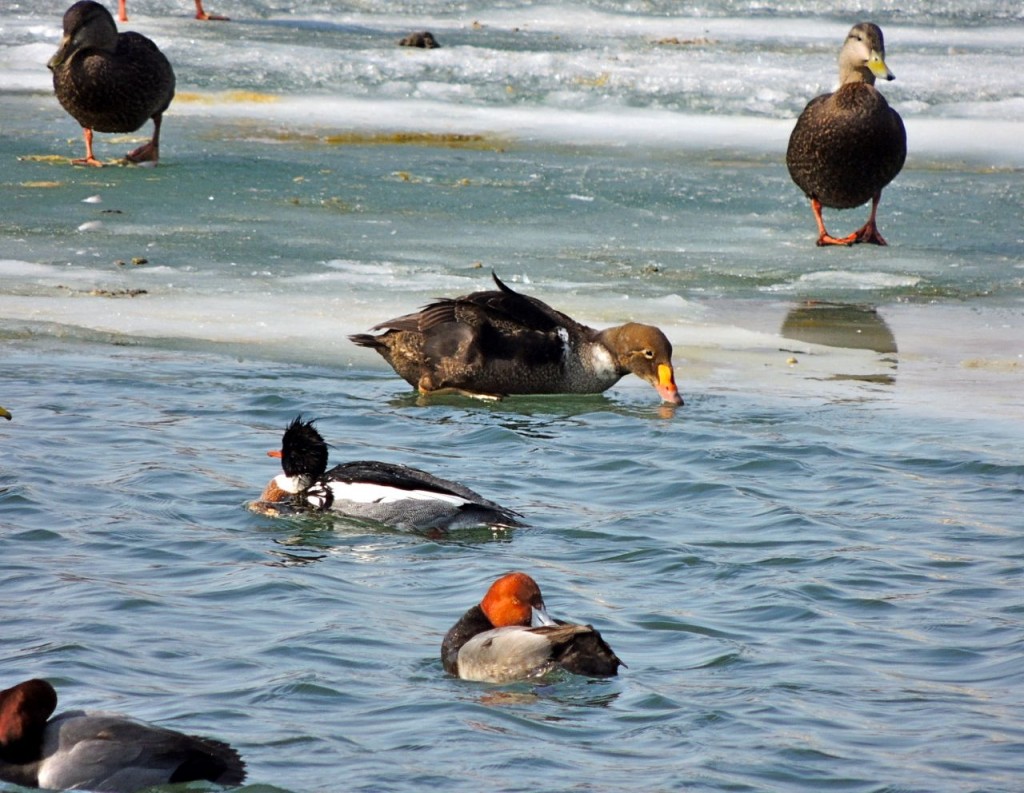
<box><xmin>260</xmin><ymin>416</ymin><xmax>521</xmax><ymax>531</ymax></box>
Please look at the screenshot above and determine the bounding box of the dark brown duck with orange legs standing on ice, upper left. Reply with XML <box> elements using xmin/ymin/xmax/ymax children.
<box><xmin>47</xmin><ymin>0</ymin><xmax>174</xmax><ymax>166</ymax></box>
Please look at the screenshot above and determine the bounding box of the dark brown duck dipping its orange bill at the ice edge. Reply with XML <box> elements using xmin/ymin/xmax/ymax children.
<box><xmin>349</xmin><ymin>274</ymin><xmax>683</xmax><ymax>405</ymax></box>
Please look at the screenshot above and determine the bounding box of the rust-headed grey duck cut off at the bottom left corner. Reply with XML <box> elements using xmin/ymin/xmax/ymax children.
<box><xmin>0</xmin><ymin>679</ymin><xmax>246</xmax><ymax>793</ymax></box>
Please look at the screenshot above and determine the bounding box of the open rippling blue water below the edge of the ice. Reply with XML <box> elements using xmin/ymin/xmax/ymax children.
<box><xmin>0</xmin><ymin>340</ymin><xmax>1024</xmax><ymax>791</ymax></box>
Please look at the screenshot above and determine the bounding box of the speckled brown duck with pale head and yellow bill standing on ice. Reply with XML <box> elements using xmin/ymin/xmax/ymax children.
<box><xmin>785</xmin><ymin>23</ymin><xmax>906</xmax><ymax>245</ymax></box>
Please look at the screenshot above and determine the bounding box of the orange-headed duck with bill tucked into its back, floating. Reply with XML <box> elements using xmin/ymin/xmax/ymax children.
<box><xmin>441</xmin><ymin>573</ymin><xmax>626</xmax><ymax>682</ymax></box>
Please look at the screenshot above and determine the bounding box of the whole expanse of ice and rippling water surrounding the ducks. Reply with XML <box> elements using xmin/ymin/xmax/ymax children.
<box><xmin>0</xmin><ymin>0</ymin><xmax>1024</xmax><ymax>793</ymax></box>
